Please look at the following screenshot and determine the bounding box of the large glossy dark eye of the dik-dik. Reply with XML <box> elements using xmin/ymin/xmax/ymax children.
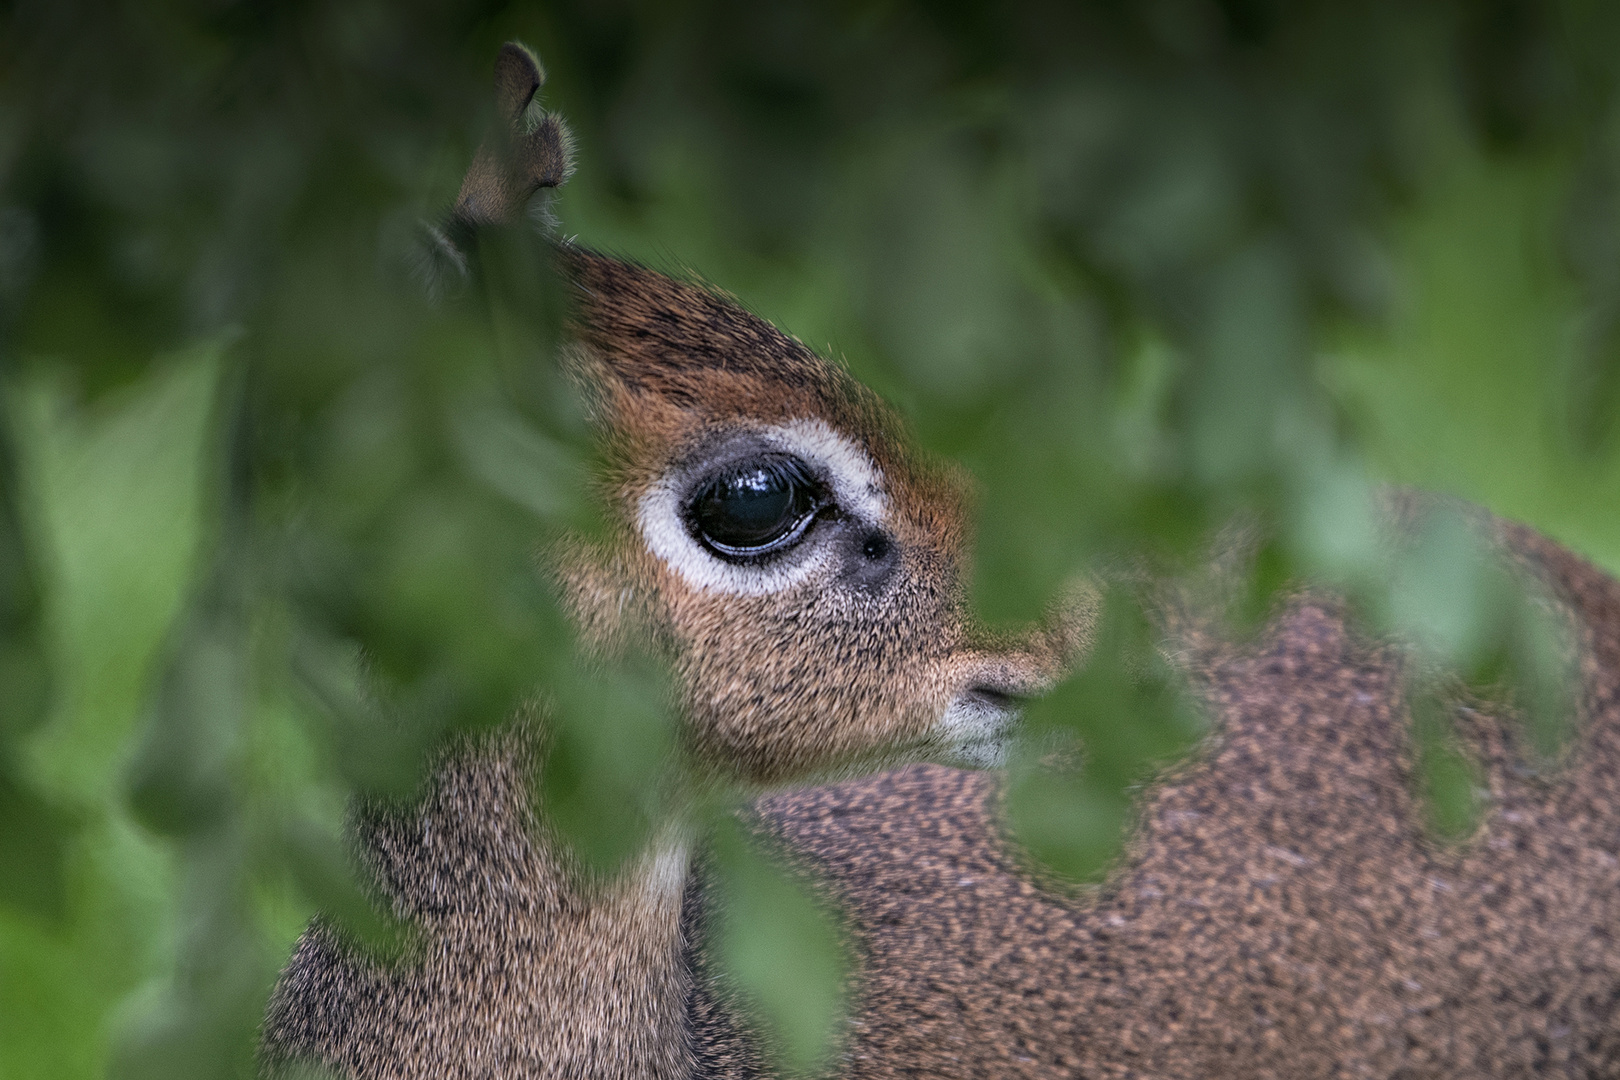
<box><xmin>687</xmin><ymin>457</ymin><xmax>826</xmax><ymax>559</ymax></box>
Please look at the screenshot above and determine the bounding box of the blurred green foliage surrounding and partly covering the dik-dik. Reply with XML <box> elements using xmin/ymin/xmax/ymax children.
<box><xmin>0</xmin><ymin>0</ymin><xmax>1620</xmax><ymax>1078</ymax></box>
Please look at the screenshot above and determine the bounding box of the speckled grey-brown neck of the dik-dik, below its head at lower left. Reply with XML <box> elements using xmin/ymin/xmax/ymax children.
<box><xmin>264</xmin><ymin>722</ymin><xmax>690</xmax><ymax>1080</ymax></box>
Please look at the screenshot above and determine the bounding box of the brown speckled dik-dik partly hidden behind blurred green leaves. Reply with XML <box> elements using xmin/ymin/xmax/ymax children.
<box><xmin>266</xmin><ymin>47</ymin><xmax>1620</xmax><ymax>1078</ymax></box>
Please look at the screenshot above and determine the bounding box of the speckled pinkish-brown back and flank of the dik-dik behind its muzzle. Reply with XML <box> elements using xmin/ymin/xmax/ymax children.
<box><xmin>729</xmin><ymin>525</ymin><xmax>1620</xmax><ymax>1080</ymax></box>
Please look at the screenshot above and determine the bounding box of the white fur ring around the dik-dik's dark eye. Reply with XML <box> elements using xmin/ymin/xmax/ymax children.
<box><xmin>637</xmin><ymin>419</ymin><xmax>888</xmax><ymax>596</ymax></box>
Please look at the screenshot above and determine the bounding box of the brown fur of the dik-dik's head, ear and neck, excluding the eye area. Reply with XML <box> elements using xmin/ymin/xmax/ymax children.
<box><xmin>262</xmin><ymin>45</ymin><xmax>1087</xmax><ymax>1080</ymax></box>
